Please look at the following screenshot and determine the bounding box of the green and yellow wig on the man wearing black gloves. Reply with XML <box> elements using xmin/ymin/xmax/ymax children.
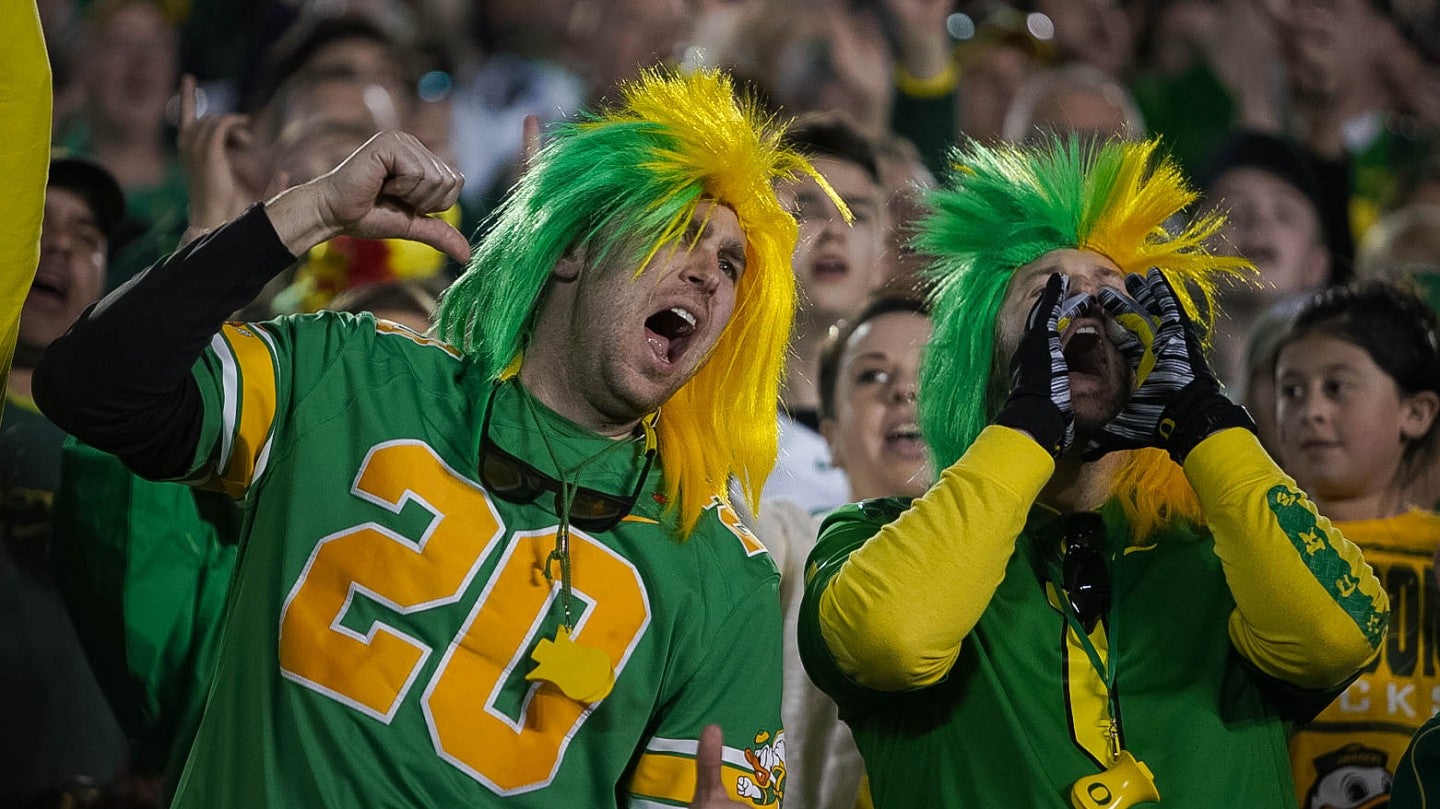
<box><xmin>914</xmin><ymin>135</ymin><xmax>1254</xmax><ymax>535</ymax></box>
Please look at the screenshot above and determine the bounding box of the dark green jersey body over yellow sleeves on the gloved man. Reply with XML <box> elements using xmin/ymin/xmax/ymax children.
<box><xmin>799</xmin><ymin>500</ymin><xmax>1331</xmax><ymax>809</ymax></box>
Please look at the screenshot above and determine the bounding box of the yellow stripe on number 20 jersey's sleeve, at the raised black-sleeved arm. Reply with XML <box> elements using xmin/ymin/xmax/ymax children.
<box><xmin>220</xmin><ymin>322</ymin><xmax>275</xmax><ymax>498</ymax></box>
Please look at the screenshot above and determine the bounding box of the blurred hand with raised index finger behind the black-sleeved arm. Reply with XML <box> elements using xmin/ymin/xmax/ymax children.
<box><xmin>179</xmin><ymin>75</ymin><xmax>259</xmax><ymax>240</ymax></box>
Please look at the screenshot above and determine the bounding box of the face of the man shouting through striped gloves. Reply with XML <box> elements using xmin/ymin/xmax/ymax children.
<box><xmin>995</xmin><ymin>249</ymin><xmax>1132</xmax><ymax>435</ymax></box>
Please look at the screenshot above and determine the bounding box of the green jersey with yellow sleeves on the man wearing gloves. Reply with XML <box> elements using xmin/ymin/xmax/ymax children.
<box><xmin>799</xmin><ymin>426</ymin><xmax>1387</xmax><ymax>809</ymax></box>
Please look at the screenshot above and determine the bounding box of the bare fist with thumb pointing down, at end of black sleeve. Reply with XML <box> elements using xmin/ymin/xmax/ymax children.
<box><xmin>265</xmin><ymin>132</ymin><xmax>469</xmax><ymax>263</ymax></box>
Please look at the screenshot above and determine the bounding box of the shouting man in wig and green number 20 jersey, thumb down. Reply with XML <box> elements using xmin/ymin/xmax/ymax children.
<box><xmin>36</xmin><ymin>72</ymin><xmax>840</xmax><ymax>808</ymax></box>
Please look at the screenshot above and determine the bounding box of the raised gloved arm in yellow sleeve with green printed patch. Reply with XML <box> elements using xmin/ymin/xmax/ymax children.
<box><xmin>1087</xmin><ymin>269</ymin><xmax>1390</xmax><ymax>690</ymax></box>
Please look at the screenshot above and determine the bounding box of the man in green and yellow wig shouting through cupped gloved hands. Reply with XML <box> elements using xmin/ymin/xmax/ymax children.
<box><xmin>799</xmin><ymin>138</ymin><xmax>1388</xmax><ymax>809</ymax></box>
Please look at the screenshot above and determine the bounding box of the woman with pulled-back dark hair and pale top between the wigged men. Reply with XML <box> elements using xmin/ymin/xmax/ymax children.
<box><xmin>759</xmin><ymin>297</ymin><xmax>935</xmax><ymax>809</ymax></box>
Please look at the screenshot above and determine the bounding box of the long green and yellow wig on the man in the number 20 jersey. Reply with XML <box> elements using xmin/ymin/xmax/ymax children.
<box><xmin>436</xmin><ymin>71</ymin><xmax>828</xmax><ymax>535</ymax></box>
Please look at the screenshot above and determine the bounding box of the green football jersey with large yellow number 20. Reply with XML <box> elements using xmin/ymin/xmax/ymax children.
<box><xmin>174</xmin><ymin>314</ymin><xmax>785</xmax><ymax>809</ymax></box>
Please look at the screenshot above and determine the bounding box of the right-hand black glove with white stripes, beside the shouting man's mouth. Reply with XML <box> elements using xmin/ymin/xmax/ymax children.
<box><xmin>1083</xmin><ymin>268</ymin><xmax>1256</xmax><ymax>464</ymax></box>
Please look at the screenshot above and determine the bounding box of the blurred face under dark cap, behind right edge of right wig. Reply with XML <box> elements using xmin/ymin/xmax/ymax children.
<box><xmin>1210</xmin><ymin>167</ymin><xmax>1329</xmax><ymax>292</ymax></box>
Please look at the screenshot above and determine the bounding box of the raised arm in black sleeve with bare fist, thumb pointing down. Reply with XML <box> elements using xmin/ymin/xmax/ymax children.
<box><xmin>35</xmin><ymin>132</ymin><xmax>469</xmax><ymax>478</ymax></box>
